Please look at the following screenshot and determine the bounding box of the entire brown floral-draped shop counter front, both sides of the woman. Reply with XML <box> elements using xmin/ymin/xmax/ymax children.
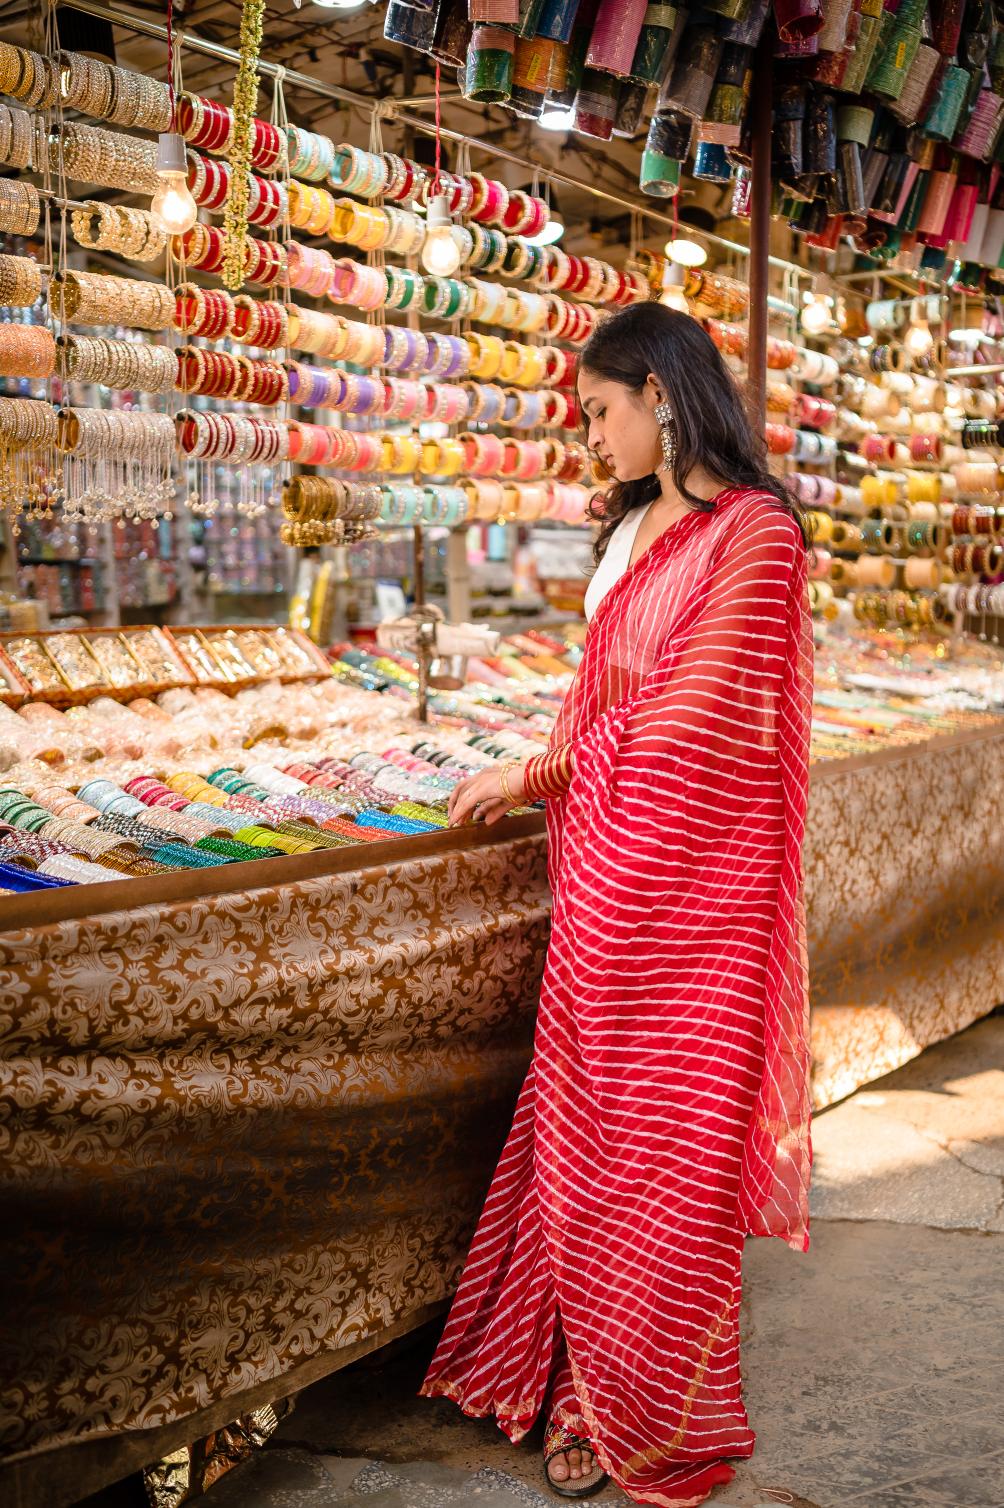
<box><xmin>0</xmin><ymin>724</ymin><xmax>1004</xmax><ymax>1508</ymax></box>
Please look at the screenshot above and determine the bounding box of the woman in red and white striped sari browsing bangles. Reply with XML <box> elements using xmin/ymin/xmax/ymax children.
<box><xmin>422</xmin><ymin>305</ymin><xmax>811</xmax><ymax>1508</ymax></box>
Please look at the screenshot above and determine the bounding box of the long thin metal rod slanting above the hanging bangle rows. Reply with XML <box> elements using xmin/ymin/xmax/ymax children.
<box><xmin>64</xmin><ymin>0</ymin><xmax>813</xmax><ymax>280</ymax></box>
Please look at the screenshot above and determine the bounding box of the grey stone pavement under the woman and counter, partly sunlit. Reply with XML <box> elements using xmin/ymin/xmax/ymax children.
<box><xmin>80</xmin><ymin>1012</ymin><xmax>1004</xmax><ymax>1508</ymax></box>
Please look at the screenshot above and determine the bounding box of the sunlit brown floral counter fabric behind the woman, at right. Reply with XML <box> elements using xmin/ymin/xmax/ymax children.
<box><xmin>805</xmin><ymin>730</ymin><xmax>1004</xmax><ymax>1110</ymax></box>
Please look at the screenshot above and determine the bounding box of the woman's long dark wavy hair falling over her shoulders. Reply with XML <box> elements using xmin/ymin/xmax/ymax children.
<box><xmin>580</xmin><ymin>303</ymin><xmax>808</xmax><ymax>566</ymax></box>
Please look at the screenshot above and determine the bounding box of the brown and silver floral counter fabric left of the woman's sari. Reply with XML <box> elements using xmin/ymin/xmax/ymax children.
<box><xmin>0</xmin><ymin>838</ymin><xmax>549</xmax><ymax>1457</ymax></box>
